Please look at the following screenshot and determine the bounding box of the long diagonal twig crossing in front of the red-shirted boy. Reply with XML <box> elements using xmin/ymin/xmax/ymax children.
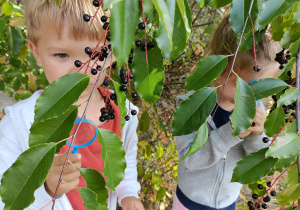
<box><xmin>52</xmin><ymin>50</ymin><xmax>112</xmax><ymax>210</ymax></box>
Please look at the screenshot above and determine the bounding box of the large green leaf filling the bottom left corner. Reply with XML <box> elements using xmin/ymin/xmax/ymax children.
<box><xmin>0</xmin><ymin>143</ymin><xmax>55</xmax><ymax>210</ymax></box>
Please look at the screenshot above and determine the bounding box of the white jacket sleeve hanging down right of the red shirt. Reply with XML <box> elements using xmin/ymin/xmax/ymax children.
<box><xmin>116</xmin><ymin>104</ymin><xmax>141</xmax><ymax>205</ymax></box>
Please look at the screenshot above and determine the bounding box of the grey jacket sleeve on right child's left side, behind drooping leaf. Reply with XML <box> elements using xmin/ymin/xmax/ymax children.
<box><xmin>176</xmin><ymin>122</ymin><xmax>243</xmax><ymax>169</ymax></box>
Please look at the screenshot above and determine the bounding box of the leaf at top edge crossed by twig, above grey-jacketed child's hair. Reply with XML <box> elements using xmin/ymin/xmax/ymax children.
<box><xmin>229</xmin><ymin>0</ymin><xmax>258</xmax><ymax>35</ymax></box>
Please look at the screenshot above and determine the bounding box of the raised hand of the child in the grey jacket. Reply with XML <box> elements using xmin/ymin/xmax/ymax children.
<box><xmin>239</xmin><ymin>107</ymin><xmax>266</xmax><ymax>138</ymax></box>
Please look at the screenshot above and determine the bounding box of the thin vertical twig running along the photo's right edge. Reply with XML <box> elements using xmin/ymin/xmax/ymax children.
<box><xmin>296</xmin><ymin>45</ymin><xmax>300</xmax><ymax>205</ymax></box>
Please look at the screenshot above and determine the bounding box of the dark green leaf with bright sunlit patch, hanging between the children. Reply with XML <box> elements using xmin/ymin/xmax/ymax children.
<box><xmin>132</xmin><ymin>46</ymin><xmax>164</xmax><ymax>104</ymax></box>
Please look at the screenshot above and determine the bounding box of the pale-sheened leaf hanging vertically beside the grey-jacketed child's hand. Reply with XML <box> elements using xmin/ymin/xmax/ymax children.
<box><xmin>230</xmin><ymin>77</ymin><xmax>256</xmax><ymax>136</ymax></box>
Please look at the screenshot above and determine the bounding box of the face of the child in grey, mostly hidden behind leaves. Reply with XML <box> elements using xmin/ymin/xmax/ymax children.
<box><xmin>217</xmin><ymin>62</ymin><xmax>279</xmax><ymax>104</ymax></box>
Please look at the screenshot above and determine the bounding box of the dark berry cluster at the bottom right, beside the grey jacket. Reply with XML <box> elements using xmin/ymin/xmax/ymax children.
<box><xmin>247</xmin><ymin>181</ymin><xmax>276</xmax><ymax>210</ymax></box>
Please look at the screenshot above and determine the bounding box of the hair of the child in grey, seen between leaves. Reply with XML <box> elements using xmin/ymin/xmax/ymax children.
<box><xmin>206</xmin><ymin>15</ymin><xmax>281</xmax><ymax>74</ymax></box>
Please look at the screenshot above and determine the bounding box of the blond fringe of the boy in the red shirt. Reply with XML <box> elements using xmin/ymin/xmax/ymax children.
<box><xmin>23</xmin><ymin>0</ymin><xmax>108</xmax><ymax>44</ymax></box>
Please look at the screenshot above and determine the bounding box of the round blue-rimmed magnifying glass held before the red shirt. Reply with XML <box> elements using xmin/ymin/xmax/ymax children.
<box><xmin>67</xmin><ymin>118</ymin><xmax>98</xmax><ymax>154</ymax></box>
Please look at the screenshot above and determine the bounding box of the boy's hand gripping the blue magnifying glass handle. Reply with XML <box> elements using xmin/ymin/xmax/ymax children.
<box><xmin>45</xmin><ymin>151</ymin><xmax>81</xmax><ymax>196</ymax></box>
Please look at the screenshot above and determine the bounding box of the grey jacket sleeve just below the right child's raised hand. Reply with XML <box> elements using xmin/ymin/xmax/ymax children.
<box><xmin>243</xmin><ymin>101</ymin><xmax>269</xmax><ymax>155</ymax></box>
